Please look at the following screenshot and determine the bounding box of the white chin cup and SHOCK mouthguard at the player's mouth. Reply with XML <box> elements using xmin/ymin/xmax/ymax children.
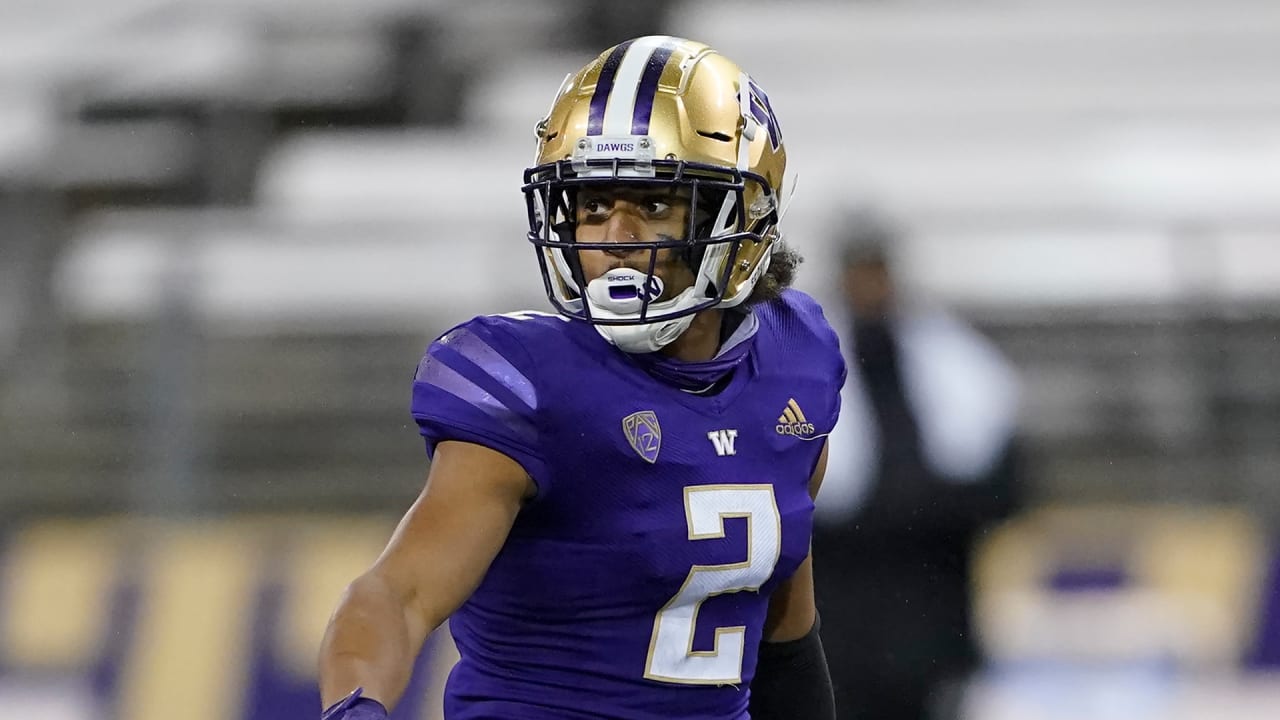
<box><xmin>586</xmin><ymin>268</ymin><xmax>694</xmax><ymax>352</ymax></box>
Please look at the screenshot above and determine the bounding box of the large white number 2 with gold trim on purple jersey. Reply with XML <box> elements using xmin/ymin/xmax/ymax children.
<box><xmin>644</xmin><ymin>484</ymin><xmax>782</xmax><ymax>685</ymax></box>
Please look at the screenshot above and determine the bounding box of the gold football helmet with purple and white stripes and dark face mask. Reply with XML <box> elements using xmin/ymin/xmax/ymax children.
<box><xmin>524</xmin><ymin>36</ymin><xmax>786</xmax><ymax>352</ymax></box>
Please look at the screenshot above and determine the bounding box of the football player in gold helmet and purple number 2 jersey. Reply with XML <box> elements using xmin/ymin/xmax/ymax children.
<box><xmin>320</xmin><ymin>36</ymin><xmax>845</xmax><ymax>720</ymax></box>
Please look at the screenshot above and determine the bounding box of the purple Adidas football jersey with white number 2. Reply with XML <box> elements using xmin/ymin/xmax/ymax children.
<box><xmin>412</xmin><ymin>291</ymin><xmax>845</xmax><ymax>720</ymax></box>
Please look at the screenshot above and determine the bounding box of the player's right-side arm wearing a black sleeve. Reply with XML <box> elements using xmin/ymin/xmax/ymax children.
<box><xmin>750</xmin><ymin>445</ymin><xmax>836</xmax><ymax>720</ymax></box>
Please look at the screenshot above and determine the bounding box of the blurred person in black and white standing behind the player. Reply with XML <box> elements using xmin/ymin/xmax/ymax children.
<box><xmin>814</xmin><ymin>209</ymin><xmax>1019</xmax><ymax>720</ymax></box>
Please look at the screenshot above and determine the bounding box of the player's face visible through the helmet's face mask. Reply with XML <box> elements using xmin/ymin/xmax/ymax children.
<box><xmin>576</xmin><ymin>184</ymin><xmax>694</xmax><ymax>300</ymax></box>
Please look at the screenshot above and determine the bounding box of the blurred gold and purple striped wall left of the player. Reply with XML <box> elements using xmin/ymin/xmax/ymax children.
<box><xmin>0</xmin><ymin>516</ymin><xmax>456</xmax><ymax>720</ymax></box>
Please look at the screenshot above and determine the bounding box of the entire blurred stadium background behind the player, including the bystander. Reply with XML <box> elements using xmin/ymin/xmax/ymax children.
<box><xmin>0</xmin><ymin>0</ymin><xmax>1280</xmax><ymax>720</ymax></box>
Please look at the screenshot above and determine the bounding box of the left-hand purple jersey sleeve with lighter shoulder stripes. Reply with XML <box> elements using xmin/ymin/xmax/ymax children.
<box><xmin>411</xmin><ymin>318</ymin><xmax>549</xmax><ymax>495</ymax></box>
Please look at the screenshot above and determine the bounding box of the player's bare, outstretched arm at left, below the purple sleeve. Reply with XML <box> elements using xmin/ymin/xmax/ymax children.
<box><xmin>320</xmin><ymin>442</ymin><xmax>534</xmax><ymax>717</ymax></box>
